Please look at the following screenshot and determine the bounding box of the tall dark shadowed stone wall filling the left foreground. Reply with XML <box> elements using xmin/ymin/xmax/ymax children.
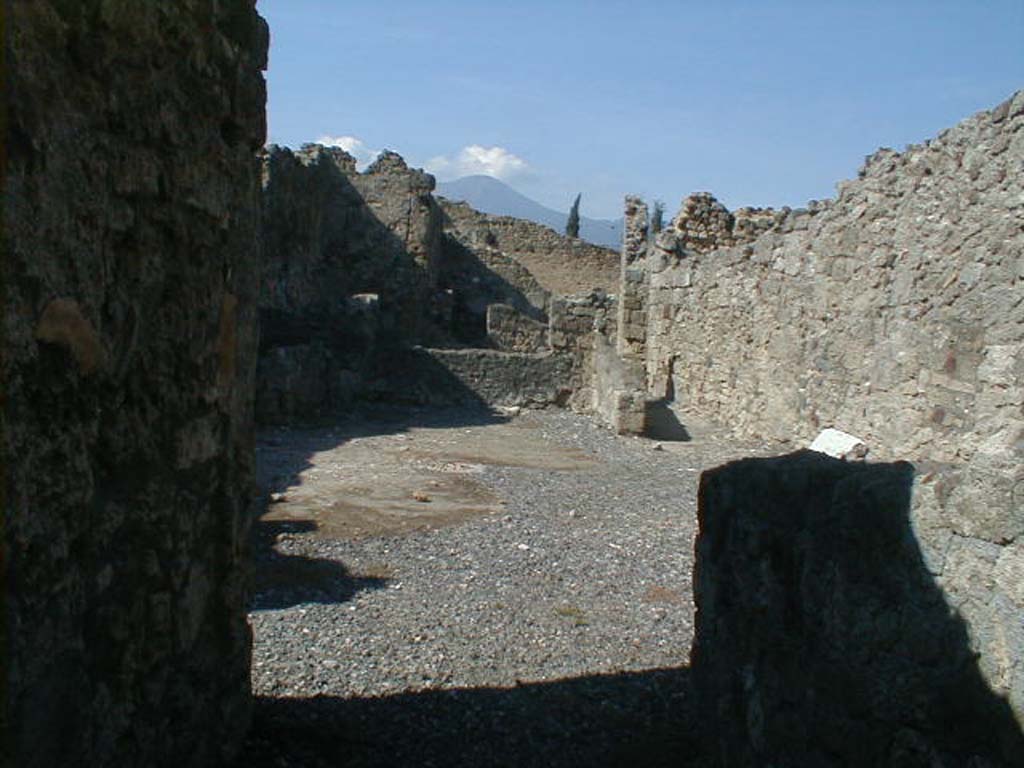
<box><xmin>0</xmin><ymin>0</ymin><xmax>267</xmax><ymax>768</ymax></box>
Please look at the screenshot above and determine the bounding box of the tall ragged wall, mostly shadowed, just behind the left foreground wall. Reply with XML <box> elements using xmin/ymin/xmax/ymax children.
<box><xmin>256</xmin><ymin>144</ymin><xmax>444</xmax><ymax>423</ymax></box>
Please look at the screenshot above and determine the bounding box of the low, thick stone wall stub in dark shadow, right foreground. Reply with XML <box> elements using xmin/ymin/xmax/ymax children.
<box><xmin>691</xmin><ymin>452</ymin><xmax>1024</xmax><ymax>768</ymax></box>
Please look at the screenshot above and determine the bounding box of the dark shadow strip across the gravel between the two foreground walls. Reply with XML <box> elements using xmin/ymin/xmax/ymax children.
<box><xmin>236</xmin><ymin>668</ymin><xmax>703</xmax><ymax>768</ymax></box>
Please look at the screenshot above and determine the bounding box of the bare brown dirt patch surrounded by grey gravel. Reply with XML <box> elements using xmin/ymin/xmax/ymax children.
<box><xmin>260</xmin><ymin>414</ymin><xmax>597</xmax><ymax>539</ymax></box>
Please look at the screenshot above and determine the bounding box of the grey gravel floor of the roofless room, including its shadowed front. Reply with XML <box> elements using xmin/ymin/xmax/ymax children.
<box><xmin>239</xmin><ymin>411</ymin><xmax>770</xmax><ymax>767</ymax></box>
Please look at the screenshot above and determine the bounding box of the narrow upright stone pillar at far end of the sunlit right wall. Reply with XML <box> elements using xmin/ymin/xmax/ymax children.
<box><xmin>616</xmin><ymin>196</ymin><xmax>648</xmax><ymax>359</ymax></box>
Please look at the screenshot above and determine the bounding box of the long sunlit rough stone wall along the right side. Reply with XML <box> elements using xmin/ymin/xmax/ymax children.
<box><xmin>647</xmin><ymin>92</ymin><xmax>1024</xmax><ymax>723</ymax></box>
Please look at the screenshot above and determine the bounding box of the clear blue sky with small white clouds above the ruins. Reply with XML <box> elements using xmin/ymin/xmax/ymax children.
<box><xmin>257</xmin><ymin>0</ymin><xmax>1024</xmax><ymax>218</ymax></box>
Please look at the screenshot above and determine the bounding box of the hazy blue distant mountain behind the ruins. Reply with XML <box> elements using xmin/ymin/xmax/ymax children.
<box><xmin>437</xmin><ymin>176</ymin><xmax>623</xmax><ymax>250</ymax></box>
